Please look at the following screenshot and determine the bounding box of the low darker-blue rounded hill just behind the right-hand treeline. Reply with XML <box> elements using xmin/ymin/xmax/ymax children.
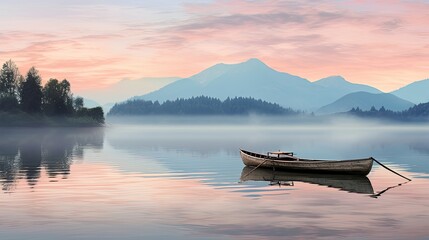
<box><xmin>316</xmin><ymin>92</ymin><xmax>414</xmax><ymax>114</ymax></box>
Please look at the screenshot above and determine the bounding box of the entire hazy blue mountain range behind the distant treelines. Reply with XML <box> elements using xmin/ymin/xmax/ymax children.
<box><xmin>82</xmin><ymin>58</ymin><xmax>429</xmax><ymax>114</ymax></box>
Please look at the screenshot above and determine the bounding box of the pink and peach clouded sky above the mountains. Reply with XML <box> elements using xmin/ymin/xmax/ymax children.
<box><xmin>0</xmin><ymin>0</ymin><xmax>429</xmax><ymax>92</ymax></box>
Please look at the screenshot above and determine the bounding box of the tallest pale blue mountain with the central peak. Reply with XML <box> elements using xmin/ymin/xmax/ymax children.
<box><xmin>133</xmin><ymin>59</ymin><xmax>377</xmax><ymax>110</ymax></box>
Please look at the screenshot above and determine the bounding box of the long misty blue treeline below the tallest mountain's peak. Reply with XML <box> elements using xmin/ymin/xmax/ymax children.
<box><xmin>108</xmin><ymin>96</ymin><xmax>299</xmax><ymax>115</ymax></box>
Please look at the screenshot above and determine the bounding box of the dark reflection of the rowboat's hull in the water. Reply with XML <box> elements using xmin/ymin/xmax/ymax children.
<box><xmin>241</xmin><ymin>167</ymin><xmax>374</xmax><ymax>194</ymax></box>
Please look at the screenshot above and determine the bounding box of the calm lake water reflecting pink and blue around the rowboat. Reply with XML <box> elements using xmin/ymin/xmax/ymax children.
<box><xmin>0</xmin><ymin>118</ymin><xmax>429</xmax><ymax>239</ymax></box>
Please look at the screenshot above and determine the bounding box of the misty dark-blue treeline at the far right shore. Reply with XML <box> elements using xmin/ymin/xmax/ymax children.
<box><xmin>348</xmin><ymin>102</ymin><xmax>429</xmax><ymax>121</ymax></box>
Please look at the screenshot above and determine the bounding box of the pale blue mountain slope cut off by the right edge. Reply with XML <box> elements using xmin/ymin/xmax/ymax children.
<box><xmin>391</xmin><ymin>79</ymin><xmax>429</xmax><ymax>104</ymax></box>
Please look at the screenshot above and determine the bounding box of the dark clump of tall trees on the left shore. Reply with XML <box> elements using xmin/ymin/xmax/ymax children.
<box><xmin>0</xmin><ymin>60</ymin><xmax>104</xmax><ymax>124</ymax></box>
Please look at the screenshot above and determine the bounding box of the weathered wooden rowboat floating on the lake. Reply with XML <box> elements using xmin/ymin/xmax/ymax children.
<box><xmin>240</xmin><ymin>149</ymin><xmax>374</xmax><ymax>176</ymax></box>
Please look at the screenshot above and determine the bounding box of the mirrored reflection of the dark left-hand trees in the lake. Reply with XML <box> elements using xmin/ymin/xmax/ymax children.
<box><xmin>0</xmin><ymin>128</ymin><xmax>104</xmax><ymax>191</ymax></box>
